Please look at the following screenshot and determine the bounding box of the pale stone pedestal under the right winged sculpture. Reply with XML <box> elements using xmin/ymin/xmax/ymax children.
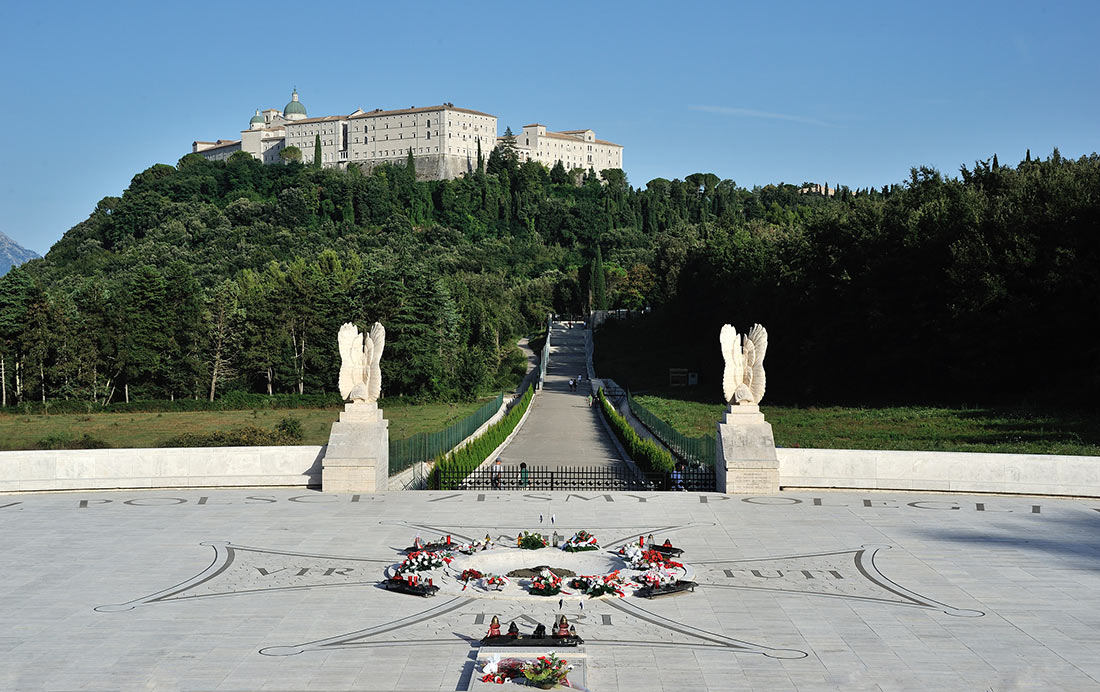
<box><xmin>715</xmin><ymin>405</ymin><xmax>779</xmax><ymax>494</ymax></box>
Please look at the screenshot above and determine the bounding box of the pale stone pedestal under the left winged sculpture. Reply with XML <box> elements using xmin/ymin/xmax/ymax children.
<box><xmin>321</xmin><ymin>402</ymin><xmax>389</xmax><ymax>493</ymax></box>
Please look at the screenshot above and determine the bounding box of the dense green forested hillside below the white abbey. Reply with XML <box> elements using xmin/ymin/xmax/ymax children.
<box><xmin>0</xmin><ymin>147</ymin><xmax>1100</xmax><ymax>405</ymax></box>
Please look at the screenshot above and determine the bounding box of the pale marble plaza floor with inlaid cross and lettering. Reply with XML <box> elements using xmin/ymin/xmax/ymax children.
<box><xmin>0</xmin><ymin>490</ymin><xmax>1100</xmax><ymax>692</ymax></box>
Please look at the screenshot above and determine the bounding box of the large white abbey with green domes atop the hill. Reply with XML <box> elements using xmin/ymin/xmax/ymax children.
<box><xmin>191</xmin><ymin>89</ymin><xmax>623</xmax><ymax>180</ymax></box>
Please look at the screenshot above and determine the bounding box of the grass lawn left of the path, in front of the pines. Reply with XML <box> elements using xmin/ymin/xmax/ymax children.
<box><xmin>0</xmin><ymin>398</ymin><xmax>490</xmax><ymax>450</ymax></box>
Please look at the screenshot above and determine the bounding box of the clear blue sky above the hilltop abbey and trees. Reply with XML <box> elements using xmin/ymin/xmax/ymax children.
<box><xmin>0</xmin><ymin>0</ymin><xmax>1100</xmax><ymax>253</ymax></box>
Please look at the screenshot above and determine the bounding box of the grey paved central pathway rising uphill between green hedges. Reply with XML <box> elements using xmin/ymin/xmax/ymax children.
<box><xmin>501</xmin><ymin>322</ymin><xmax>623</xmax><ymax>468</ymax></box>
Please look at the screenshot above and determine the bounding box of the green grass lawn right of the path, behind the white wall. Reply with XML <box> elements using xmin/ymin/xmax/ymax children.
<box><xmin>635</xmin><ymin>396</ymin><xmax>1100</xmax><ymax>455</ymax></box>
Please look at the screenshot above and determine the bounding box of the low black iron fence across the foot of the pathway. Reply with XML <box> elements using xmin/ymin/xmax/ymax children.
<box><xmin>439</xmin><ymin>465</ymin><xmax>715</xmax><ymax>493</ymax></box>
